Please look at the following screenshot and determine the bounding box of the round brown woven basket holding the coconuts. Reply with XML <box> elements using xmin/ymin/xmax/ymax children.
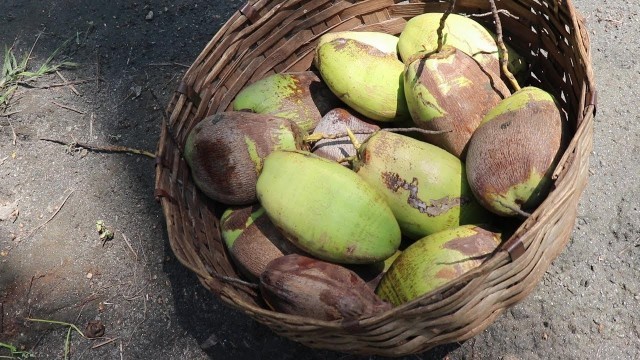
<box><xmin>156</xmin><ymin>0</ymin><xmax>595</xmax><ymax>356</ymax></box>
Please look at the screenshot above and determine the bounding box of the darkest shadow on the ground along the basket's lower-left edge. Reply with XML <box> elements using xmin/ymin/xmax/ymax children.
<box><xmin>163</xmin><ymin>236</ymin><xmax>461</xmax><ymax>360</ymax></box>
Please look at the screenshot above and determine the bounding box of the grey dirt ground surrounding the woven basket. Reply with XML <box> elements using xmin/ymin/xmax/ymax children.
<box><xmin>0</xmin><ymin>0</ymin><xmax>640</xmax><ymax>360</ymax></box>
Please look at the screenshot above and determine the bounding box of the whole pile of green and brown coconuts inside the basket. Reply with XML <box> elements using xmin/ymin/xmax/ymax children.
<box><xmin>184</xmin><ymin>12</ymin><xmax>566</xmax><ymax>320</ymax></box>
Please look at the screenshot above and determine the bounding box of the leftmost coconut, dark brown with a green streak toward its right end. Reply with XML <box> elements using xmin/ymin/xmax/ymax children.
<box><xmin>184</xmin><ymin>111</ymin><xmax>306</xmax><ymax>205</ymax></box>
